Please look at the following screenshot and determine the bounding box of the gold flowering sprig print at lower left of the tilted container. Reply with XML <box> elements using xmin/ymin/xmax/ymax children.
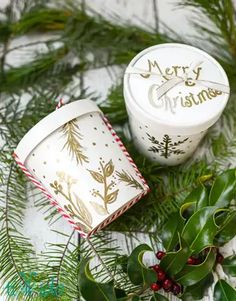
<box><xmin>50</xmin><ymin>172</ymin><xmax>93</xmax><ymax>232</ymax></box>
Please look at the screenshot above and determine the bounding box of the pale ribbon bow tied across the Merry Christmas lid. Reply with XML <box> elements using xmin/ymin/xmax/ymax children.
<box><xmin>125</xmin><ymin>62</ymin><xmax>230</xmax><ymax>99</ymax></box>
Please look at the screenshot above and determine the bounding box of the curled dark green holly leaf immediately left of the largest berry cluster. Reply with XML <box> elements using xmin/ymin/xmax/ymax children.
<box><xmin>127</xmin><ymin>244</ymin><xmax>156</xmax><ymax>285</ymax></box>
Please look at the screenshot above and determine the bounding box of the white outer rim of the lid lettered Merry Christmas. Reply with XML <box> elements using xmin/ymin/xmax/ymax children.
<box><xmin>123</xmin><ymin>43</ymin><xmax>230</xmax><ymax>134</ymax></box>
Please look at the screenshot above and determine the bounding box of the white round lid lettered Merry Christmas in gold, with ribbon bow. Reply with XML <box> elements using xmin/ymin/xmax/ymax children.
<box><xmin>124</xmin><ymin>43</ymin><xmax>229</xmax><ymax>134</ymax></box>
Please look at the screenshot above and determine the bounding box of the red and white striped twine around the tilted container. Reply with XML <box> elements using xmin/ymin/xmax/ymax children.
<box><xmin>13</xmin><ymin>98</ymin><xmax>150</xmax><ymax>237</ymax></box>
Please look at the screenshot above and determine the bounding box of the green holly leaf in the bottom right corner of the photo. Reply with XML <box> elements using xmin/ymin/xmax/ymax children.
<box><xmin>214</xmin><ymin>280</ymin><xmax>236</xmax><ymax>301</ymax></box>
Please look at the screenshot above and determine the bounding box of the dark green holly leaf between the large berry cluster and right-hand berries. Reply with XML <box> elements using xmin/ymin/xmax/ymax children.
<box><xmin>160</xmin><ymin>234</ymin><xmax>191</xmax><ymax>277</ymax></box>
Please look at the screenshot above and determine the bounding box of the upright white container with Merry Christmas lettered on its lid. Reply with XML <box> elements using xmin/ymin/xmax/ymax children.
<box><xmin>124</xmin><ymin>43</ymin><xmax>229</xmax><ymax>165</ymax></box>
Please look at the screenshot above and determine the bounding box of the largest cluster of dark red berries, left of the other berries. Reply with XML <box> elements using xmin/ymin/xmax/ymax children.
<box><xmin>151</xmin><ymin>251</ymin><xmax>182</xmax><ymax>295</ymax></box>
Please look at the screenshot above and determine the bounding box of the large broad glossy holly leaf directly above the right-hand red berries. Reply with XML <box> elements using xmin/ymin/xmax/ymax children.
<box><xmin>181</xmin><ymin>206</ymin><xmax>218</xmax><ymax>254</ymax></box>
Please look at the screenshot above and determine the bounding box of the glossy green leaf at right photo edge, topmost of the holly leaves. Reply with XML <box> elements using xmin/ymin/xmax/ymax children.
<box><xmin>209</xmin><ymin>169</ymin><xmax>236</xmax><ymax>208</ymax></box>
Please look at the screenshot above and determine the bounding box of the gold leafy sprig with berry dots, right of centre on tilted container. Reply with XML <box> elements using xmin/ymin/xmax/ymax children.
<box><xmin>88</xmin><ymin>160</ymin><xmax>119</xmax><ymax>215</ymax></box>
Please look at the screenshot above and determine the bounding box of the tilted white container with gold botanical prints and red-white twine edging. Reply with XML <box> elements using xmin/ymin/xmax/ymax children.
<box><xmin>14</xmin><ymin>100</ymin><xmax>149</xmax><ymax>236</ymax></box>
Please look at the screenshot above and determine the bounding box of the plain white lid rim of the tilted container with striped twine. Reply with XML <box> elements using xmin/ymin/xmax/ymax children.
<box><xmin>15</xmin><ymin>99</ymin><xmax>102</xmax><ymax>163</ymax></box>
